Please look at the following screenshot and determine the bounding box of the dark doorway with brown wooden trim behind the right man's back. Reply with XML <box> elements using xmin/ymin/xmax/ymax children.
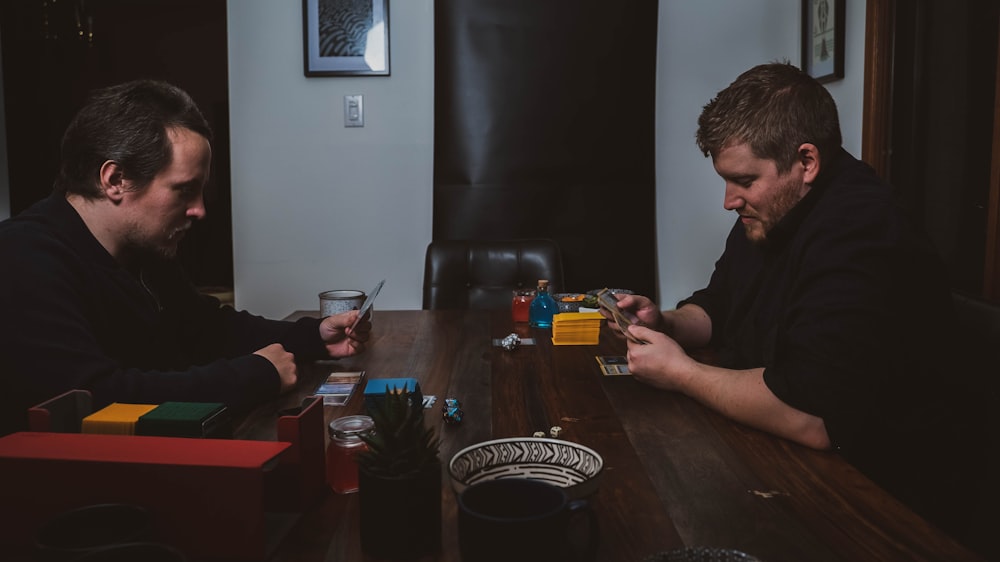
<box><xmin>863</xmin><ymin>0</ymin><xmax>1000</xmax><ymax>302</ymax></box>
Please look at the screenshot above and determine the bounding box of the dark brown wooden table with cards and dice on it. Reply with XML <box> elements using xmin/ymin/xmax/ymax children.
<box><xmin>237</xmin><ymin>310</ymin><xmax>980</xmax><ymax>562</ymax></box>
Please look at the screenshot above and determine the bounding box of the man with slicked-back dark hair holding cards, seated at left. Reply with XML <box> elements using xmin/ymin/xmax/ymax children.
<box><xmin>0</xmin><ymin>80</ymin><xmax>371</xmax><ymax>435</ymax></box>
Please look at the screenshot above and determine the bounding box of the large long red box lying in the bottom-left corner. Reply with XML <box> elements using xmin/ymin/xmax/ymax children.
<box><xmin>0</xmin><ymin>432</ymin><xmax>294</xmax><ymax>560</ymax></box>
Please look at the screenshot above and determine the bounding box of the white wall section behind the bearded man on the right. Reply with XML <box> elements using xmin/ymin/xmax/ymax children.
<box><xmin>656</xmin><ymin>0</ymin><xmax>865</xmax><ymax>308</ymax></box>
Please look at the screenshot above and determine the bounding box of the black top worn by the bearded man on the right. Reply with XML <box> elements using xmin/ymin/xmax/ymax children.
<box><xmin>680</xmin><ymin>152</ymin><xmax>981</xmax><ymax>532</ymax></box>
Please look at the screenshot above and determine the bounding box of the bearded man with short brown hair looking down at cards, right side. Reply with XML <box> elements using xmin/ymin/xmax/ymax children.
<box><xmin>609</xmin><ymin>63</ymin><xmax>983</xmax><ymax>544</ymax></box>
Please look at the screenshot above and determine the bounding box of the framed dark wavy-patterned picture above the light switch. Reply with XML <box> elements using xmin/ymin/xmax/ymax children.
<box><xmin>302</xmin><ymin>0</ymin><xmax>389</xmax><ymax>76</ymax></box>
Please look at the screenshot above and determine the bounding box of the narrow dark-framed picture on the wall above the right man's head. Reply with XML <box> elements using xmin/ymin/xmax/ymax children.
<box><xmin>802</xmin><ymin>0</ymin><xmax>844</xmax><ymax>82</ymax></box>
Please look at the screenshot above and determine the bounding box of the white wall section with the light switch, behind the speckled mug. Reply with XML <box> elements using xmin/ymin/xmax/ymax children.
<box><xmin>228</xmin><ymin>0</ymin><xmax>434</xmax><ymax>318</ymax></box>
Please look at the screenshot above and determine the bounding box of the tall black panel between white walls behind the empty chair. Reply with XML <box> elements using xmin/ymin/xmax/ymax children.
<box><xmin>434</xmin><ymin>0</ymin><xmax>657</xmax><ymax>295</ymax></box>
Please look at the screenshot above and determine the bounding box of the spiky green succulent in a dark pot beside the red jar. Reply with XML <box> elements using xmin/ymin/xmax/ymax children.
<box><xmin>357</xmin><ymin>388</ymin><xmax>441</xmax><ymax>559</ymax></box>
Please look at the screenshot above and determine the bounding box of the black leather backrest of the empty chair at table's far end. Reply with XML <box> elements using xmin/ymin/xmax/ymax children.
<box><xmin>423</xmin><ymin>239</ymin><xmax>563</xmax><ymax>310</ymax></box>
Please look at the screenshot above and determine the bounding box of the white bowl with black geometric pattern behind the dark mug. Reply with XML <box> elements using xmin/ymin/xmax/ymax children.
<box><xmin>448</xmin><ymin>437</ymin><xmax>604</xmax><ymax>499</ymax></box>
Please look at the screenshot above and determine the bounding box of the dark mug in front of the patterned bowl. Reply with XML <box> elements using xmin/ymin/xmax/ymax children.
<box><xmin>458</xmin><ymin>478</ymin><xmax>598</xmax><ymax>562</ymax></box>
